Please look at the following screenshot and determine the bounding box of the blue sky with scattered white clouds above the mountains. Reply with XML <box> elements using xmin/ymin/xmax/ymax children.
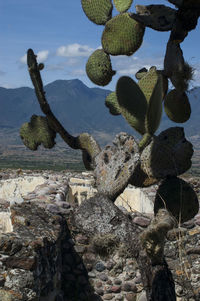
<box><xmin>0</xmin><ymin>0</ymin><xmax>200</xmax><ymax>90</ymax></box>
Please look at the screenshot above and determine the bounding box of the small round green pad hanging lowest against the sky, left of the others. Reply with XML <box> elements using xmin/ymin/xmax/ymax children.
<box><xmin>86</xmin><ymin>49</ymin><xmax>116</xmax><ymax>86</ymax></box>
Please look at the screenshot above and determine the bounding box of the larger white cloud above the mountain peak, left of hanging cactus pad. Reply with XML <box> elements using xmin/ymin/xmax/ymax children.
<box><xmin>57</xmin><ymin>43</ymin><xmax>95</xmax><ymax>57</ymax></box>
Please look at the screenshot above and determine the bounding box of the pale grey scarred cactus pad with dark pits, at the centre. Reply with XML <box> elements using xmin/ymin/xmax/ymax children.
<box><xmin>94</xmin><ymin>133</ymin><xmax>140</xmax><ymax>201</ymax></box>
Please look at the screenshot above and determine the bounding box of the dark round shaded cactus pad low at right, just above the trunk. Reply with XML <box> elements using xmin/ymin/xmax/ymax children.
<box><xmin>154</xmin><ymin>177</ymin><xmax>199</xmax><ymax>223</ymax></box>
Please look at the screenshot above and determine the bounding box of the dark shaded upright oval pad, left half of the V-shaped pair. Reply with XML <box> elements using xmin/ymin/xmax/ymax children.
<box><xmin>116</xmin><ymin>76</ymin><xmax>147</xmax><ymax>135</ymax></box>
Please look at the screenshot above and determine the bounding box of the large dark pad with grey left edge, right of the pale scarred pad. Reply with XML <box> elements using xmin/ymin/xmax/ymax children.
<box><xmin>141</xmin><ymin>127</ymin><xmax>193</xmax><ymax>179</ymax></box>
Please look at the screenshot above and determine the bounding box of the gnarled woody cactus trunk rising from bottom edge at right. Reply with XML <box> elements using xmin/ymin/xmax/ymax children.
<box><xmin>140</xmin><ymin>209</ymin><xmax>177</xmax><ymax>301</ymax></box>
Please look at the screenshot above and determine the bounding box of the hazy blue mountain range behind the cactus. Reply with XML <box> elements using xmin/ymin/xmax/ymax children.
<box><xmin>0</xmin><ymin>79</ymin><xmax>200</xmax><ymax>144</ymax></box>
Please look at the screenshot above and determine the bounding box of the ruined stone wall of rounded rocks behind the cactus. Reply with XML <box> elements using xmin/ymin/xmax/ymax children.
<box><xmin>0</xmin><ymin>170</ymin><xmax>200</xmax><ymax>301</ymax></box>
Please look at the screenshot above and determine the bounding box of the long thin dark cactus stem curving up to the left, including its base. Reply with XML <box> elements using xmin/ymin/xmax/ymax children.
<box><xmin>27</xmin><ymin>49</ymin><xmax>101</xmax><ymax>169</ymax></box>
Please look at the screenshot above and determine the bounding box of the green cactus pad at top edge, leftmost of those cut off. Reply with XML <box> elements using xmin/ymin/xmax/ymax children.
<box><xmin>81</xmin><ymin>0</ymin><xmax>113</xmax><ymax>25</ymax></box>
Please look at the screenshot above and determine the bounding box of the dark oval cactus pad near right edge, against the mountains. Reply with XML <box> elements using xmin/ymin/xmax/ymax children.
<box><xmin>164</xmin><ymin>89</ymin><xmax>191</xmax><ymax>123</ymax></box>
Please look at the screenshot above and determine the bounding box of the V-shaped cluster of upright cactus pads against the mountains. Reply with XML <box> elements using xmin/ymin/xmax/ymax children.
<box><xmin>116</xmin><ymin>67</ymin><xmax>163</xmax><ymax>135</ymax></box>
